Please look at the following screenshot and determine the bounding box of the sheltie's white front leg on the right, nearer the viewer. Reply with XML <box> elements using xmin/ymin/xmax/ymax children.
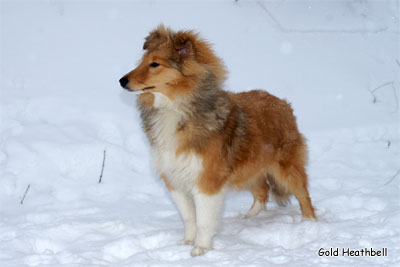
<box><xmin>191</xmin><ymin>189</ymin><xmax>226</xmax><ymax>256</ymax></box>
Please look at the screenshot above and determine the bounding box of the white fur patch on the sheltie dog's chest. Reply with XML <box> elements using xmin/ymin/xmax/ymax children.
<box><xmin>147</xmin><ymin>102</ymin><xmax>203</xmax><ymax>191</ymax></box>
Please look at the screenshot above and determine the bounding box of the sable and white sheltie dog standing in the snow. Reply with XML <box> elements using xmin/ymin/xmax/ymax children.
<box><xmin>119</xmin><ymin>25</ymin><xmax>316</xmax><ymax>256</ymax></box>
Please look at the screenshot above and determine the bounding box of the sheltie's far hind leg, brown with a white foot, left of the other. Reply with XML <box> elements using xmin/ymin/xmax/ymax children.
<box><xmin>243</xmin><ymin>177</ymin><xmax>269</xmax><ymax>219</ymax></box>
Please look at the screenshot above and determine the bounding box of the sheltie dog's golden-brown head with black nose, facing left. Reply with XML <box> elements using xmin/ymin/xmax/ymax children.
<box><xmin>119</xmin><ymin>25</ymin><xmax>226</xmax><ymax>104</ymax></box>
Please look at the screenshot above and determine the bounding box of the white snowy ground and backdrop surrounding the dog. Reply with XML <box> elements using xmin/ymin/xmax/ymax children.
<box><xmin>0</xmin><ymin>0</ymin><xmax>400</xmax><ymax>267</ymax></box>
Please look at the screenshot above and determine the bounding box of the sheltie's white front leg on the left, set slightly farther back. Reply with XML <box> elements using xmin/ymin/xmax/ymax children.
<box><xmin>171</xmin><ymin>190</ymin><xmax>196</xmax><ymax>245</ymax></box>
